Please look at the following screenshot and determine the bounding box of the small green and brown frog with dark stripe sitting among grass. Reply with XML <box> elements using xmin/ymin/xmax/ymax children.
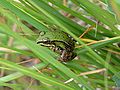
<box><xmin>36</xmin><ymin>30</ymin><xmax>76</xmax><ymax>62</ymax></box>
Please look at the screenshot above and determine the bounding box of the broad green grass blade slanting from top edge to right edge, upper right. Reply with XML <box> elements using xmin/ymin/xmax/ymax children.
<box><xmin>72</xmin><ymin>0</ymin><xmax>120</xmax><ymax>36</ymax></box>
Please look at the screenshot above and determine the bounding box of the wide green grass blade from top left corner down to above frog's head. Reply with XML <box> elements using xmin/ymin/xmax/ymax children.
<box><xmin>0</xmin><ymin>0</ymin><xmax>48</xmax><ymax>31</ymax></box>
